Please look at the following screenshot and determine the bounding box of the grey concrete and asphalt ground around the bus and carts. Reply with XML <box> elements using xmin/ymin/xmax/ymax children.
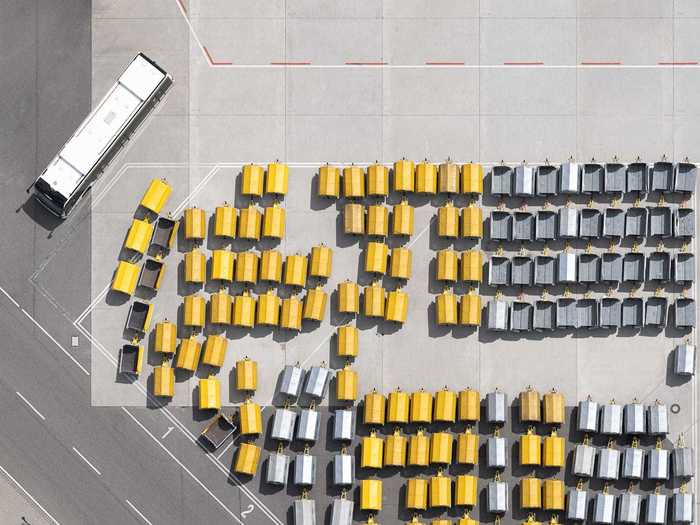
<box><xmin>0</xmin><ymin>0</ymin><xmax>700</xmax><ymax>524</ymax></box>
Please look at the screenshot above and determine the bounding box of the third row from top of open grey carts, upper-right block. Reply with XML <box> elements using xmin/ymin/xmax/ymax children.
<box><xmin>488</xmin><ymin>250</ymin><xmax>695</xmax><ymax>286</ymax></box>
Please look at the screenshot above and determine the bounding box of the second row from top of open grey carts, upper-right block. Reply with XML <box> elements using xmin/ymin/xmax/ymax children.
<box><xmin>489</xmin><ymin>206</ymin><xmax>695</xmax><ymax>241</ymax></box>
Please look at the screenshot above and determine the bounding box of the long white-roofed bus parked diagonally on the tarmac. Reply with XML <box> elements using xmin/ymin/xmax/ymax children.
<box><xmin>28</xmin><ymin>53</ymin><xmax>173</xmax><ymax>218</ymax></box>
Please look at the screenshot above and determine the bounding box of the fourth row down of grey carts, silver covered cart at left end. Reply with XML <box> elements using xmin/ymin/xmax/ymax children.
<box><xmin>486</xmin><ymin>296</ymin><xmax>695</xmax><ymax>332</ymax></box>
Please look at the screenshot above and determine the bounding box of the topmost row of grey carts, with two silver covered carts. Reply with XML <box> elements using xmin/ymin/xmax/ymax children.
<box><xmin>490</xmin><ymin>160</ymin><xmax>697</xmax><ymax>197</ymax></box>
